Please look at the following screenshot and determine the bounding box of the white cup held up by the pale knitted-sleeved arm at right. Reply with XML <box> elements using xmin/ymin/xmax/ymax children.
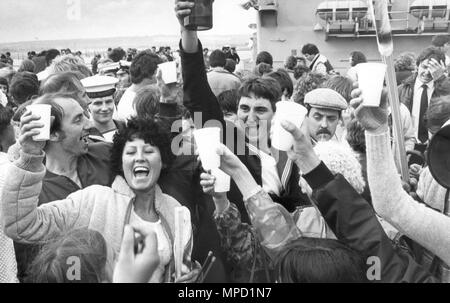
<box><xmin>356</xmin><ymin>63</ymin><xmax>387</xmax><ymax>107</ymax></box>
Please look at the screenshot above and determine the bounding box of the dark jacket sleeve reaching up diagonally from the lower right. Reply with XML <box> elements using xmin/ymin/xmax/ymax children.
<box><xmin>304</xmin><ymin>163</ymin><xmax>439</xmax><ymax>283</ymax></box>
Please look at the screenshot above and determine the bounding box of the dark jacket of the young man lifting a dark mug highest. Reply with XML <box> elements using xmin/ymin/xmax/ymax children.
<box><xmin>180</xmin><ymin>41</ymin><xmax>310</xmax><ymax>223</ymax></box>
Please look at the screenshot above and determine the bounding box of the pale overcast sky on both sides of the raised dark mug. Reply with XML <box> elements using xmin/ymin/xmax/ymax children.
<box><xmin>0</xmin><ymin>0</ymin><xmax>255</xmax><ymax>42</ymax></box>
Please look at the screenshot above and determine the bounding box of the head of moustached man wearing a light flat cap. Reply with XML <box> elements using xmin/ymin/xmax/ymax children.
<box><xmin>305</xmin><ymin>88</ymin><xmax>348</xmax><ymax>142</ymax></box>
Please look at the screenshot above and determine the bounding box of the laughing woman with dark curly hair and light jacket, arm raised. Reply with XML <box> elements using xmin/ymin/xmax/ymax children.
<box><xmin>2</xmin><ymin>112</ymin><xmax>199</xmax><ymax>283</ymax></box>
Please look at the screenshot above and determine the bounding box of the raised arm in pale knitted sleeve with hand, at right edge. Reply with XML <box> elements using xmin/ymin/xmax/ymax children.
<box><xmin>352</xmin><ymin>90</ymin><xmax>450</xmax><ymax>264</ymax></box>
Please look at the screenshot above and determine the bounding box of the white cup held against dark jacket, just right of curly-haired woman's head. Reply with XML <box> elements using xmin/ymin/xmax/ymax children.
<box><xmin>194</xmin><ymin>127</ymin><xmax>220</xmax><ymax>170</ymax></box>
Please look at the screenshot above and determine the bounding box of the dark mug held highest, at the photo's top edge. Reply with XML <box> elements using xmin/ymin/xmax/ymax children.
<box><xmin>184</xmin><ymin>0</ymin><xmax>214</xmax><ymax>31</ymax></box>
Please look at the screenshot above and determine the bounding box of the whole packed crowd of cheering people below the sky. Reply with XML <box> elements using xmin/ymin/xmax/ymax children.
<box><xmin>0</xmin><ymin>0</ymin><xmax>450</xmax><ymax>283</ymax></box>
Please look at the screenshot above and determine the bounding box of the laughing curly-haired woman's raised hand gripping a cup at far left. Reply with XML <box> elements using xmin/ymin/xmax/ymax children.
<box><xmin>19</xmin><ymin>110</ymin><xmax>45</xmax><ymax>155</ymax></box>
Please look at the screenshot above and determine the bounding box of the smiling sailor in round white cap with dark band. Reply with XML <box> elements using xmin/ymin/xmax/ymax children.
<box><xmin>81</xmin><ymin>75</ymin><xmax>125</xmax><ymax>143</ymax></box>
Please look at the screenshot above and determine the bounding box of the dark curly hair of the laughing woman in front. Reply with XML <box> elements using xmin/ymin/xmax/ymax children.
<box><xmin>111</xmin><ymin>118</ymin><xmax>174</xmax><ymax>177</ymax></box>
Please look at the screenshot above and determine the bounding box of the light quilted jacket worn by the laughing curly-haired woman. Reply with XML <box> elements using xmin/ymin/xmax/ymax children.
<box><xmin>1</xmin><ymin>152</ymin><xmax>192</xmax><ymax>281</ymax></box>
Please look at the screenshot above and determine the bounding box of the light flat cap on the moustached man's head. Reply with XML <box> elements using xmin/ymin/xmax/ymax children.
<box><xmin>305</xmin><ymin>88</ymin><xmax>348</xmax><ymax>111</ymax></box>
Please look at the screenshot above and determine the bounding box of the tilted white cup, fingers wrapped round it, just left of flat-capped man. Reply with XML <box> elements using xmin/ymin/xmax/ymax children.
<box><xmin>272</xmin><ymin>101</ymin><xmax>308</xmax><ymax>151</ymax></box>
